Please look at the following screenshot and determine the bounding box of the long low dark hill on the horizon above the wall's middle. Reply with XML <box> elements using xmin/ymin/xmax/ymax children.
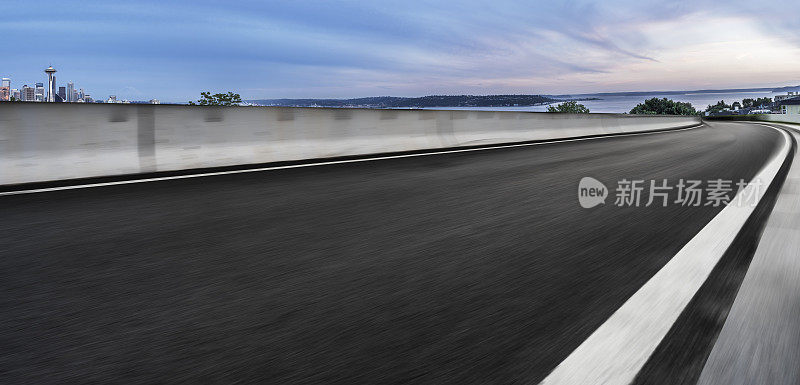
<box><xmin>247</xmin><ymin>95</ymin><xmax>561</xmax><ymax>108</ymax></box>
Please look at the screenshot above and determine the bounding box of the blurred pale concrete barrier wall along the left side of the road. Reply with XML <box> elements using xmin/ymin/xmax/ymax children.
<box><xmin>0</xmin><ymin>103</ymin><xmax>700</xmax><ymax>184</ymax></box>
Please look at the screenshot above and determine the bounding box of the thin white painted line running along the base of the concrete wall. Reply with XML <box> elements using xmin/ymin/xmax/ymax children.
<box><xmin>0</xmin><ymin>123</ymin><xmax>705</xmax><ymax>196</ymax></box>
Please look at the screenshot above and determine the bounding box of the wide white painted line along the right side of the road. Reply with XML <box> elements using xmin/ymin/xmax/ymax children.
<box><xmin>542</xmin><ymin>127</ymin><xmax>791</xmax><ymax>385</ymax></box>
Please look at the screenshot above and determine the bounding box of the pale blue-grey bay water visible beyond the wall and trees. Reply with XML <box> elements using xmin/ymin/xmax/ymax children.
<box><xmin>422</xmin><ymin>91</ymin><xmax>786</xmax><ymax>113</ymax></box>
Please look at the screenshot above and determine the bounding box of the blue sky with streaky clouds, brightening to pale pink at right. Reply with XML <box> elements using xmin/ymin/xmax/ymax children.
<box><xmin>0</xmin><ymin>0</ymin><xmax>800</xmax><ymax>102</ymax></box>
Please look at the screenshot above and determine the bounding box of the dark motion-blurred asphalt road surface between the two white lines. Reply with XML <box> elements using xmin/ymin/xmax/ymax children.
<box><xmin>0</xmin><ymin>119</ymin><xmax>782</xmax><ymax>384</ymax></box>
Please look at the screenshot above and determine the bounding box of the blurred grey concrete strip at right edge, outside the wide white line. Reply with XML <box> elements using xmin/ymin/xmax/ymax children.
<box><xmin>697</xmin><ymin>124</ymin><xmax>800</xmax><ymax>385</ymax></box>
